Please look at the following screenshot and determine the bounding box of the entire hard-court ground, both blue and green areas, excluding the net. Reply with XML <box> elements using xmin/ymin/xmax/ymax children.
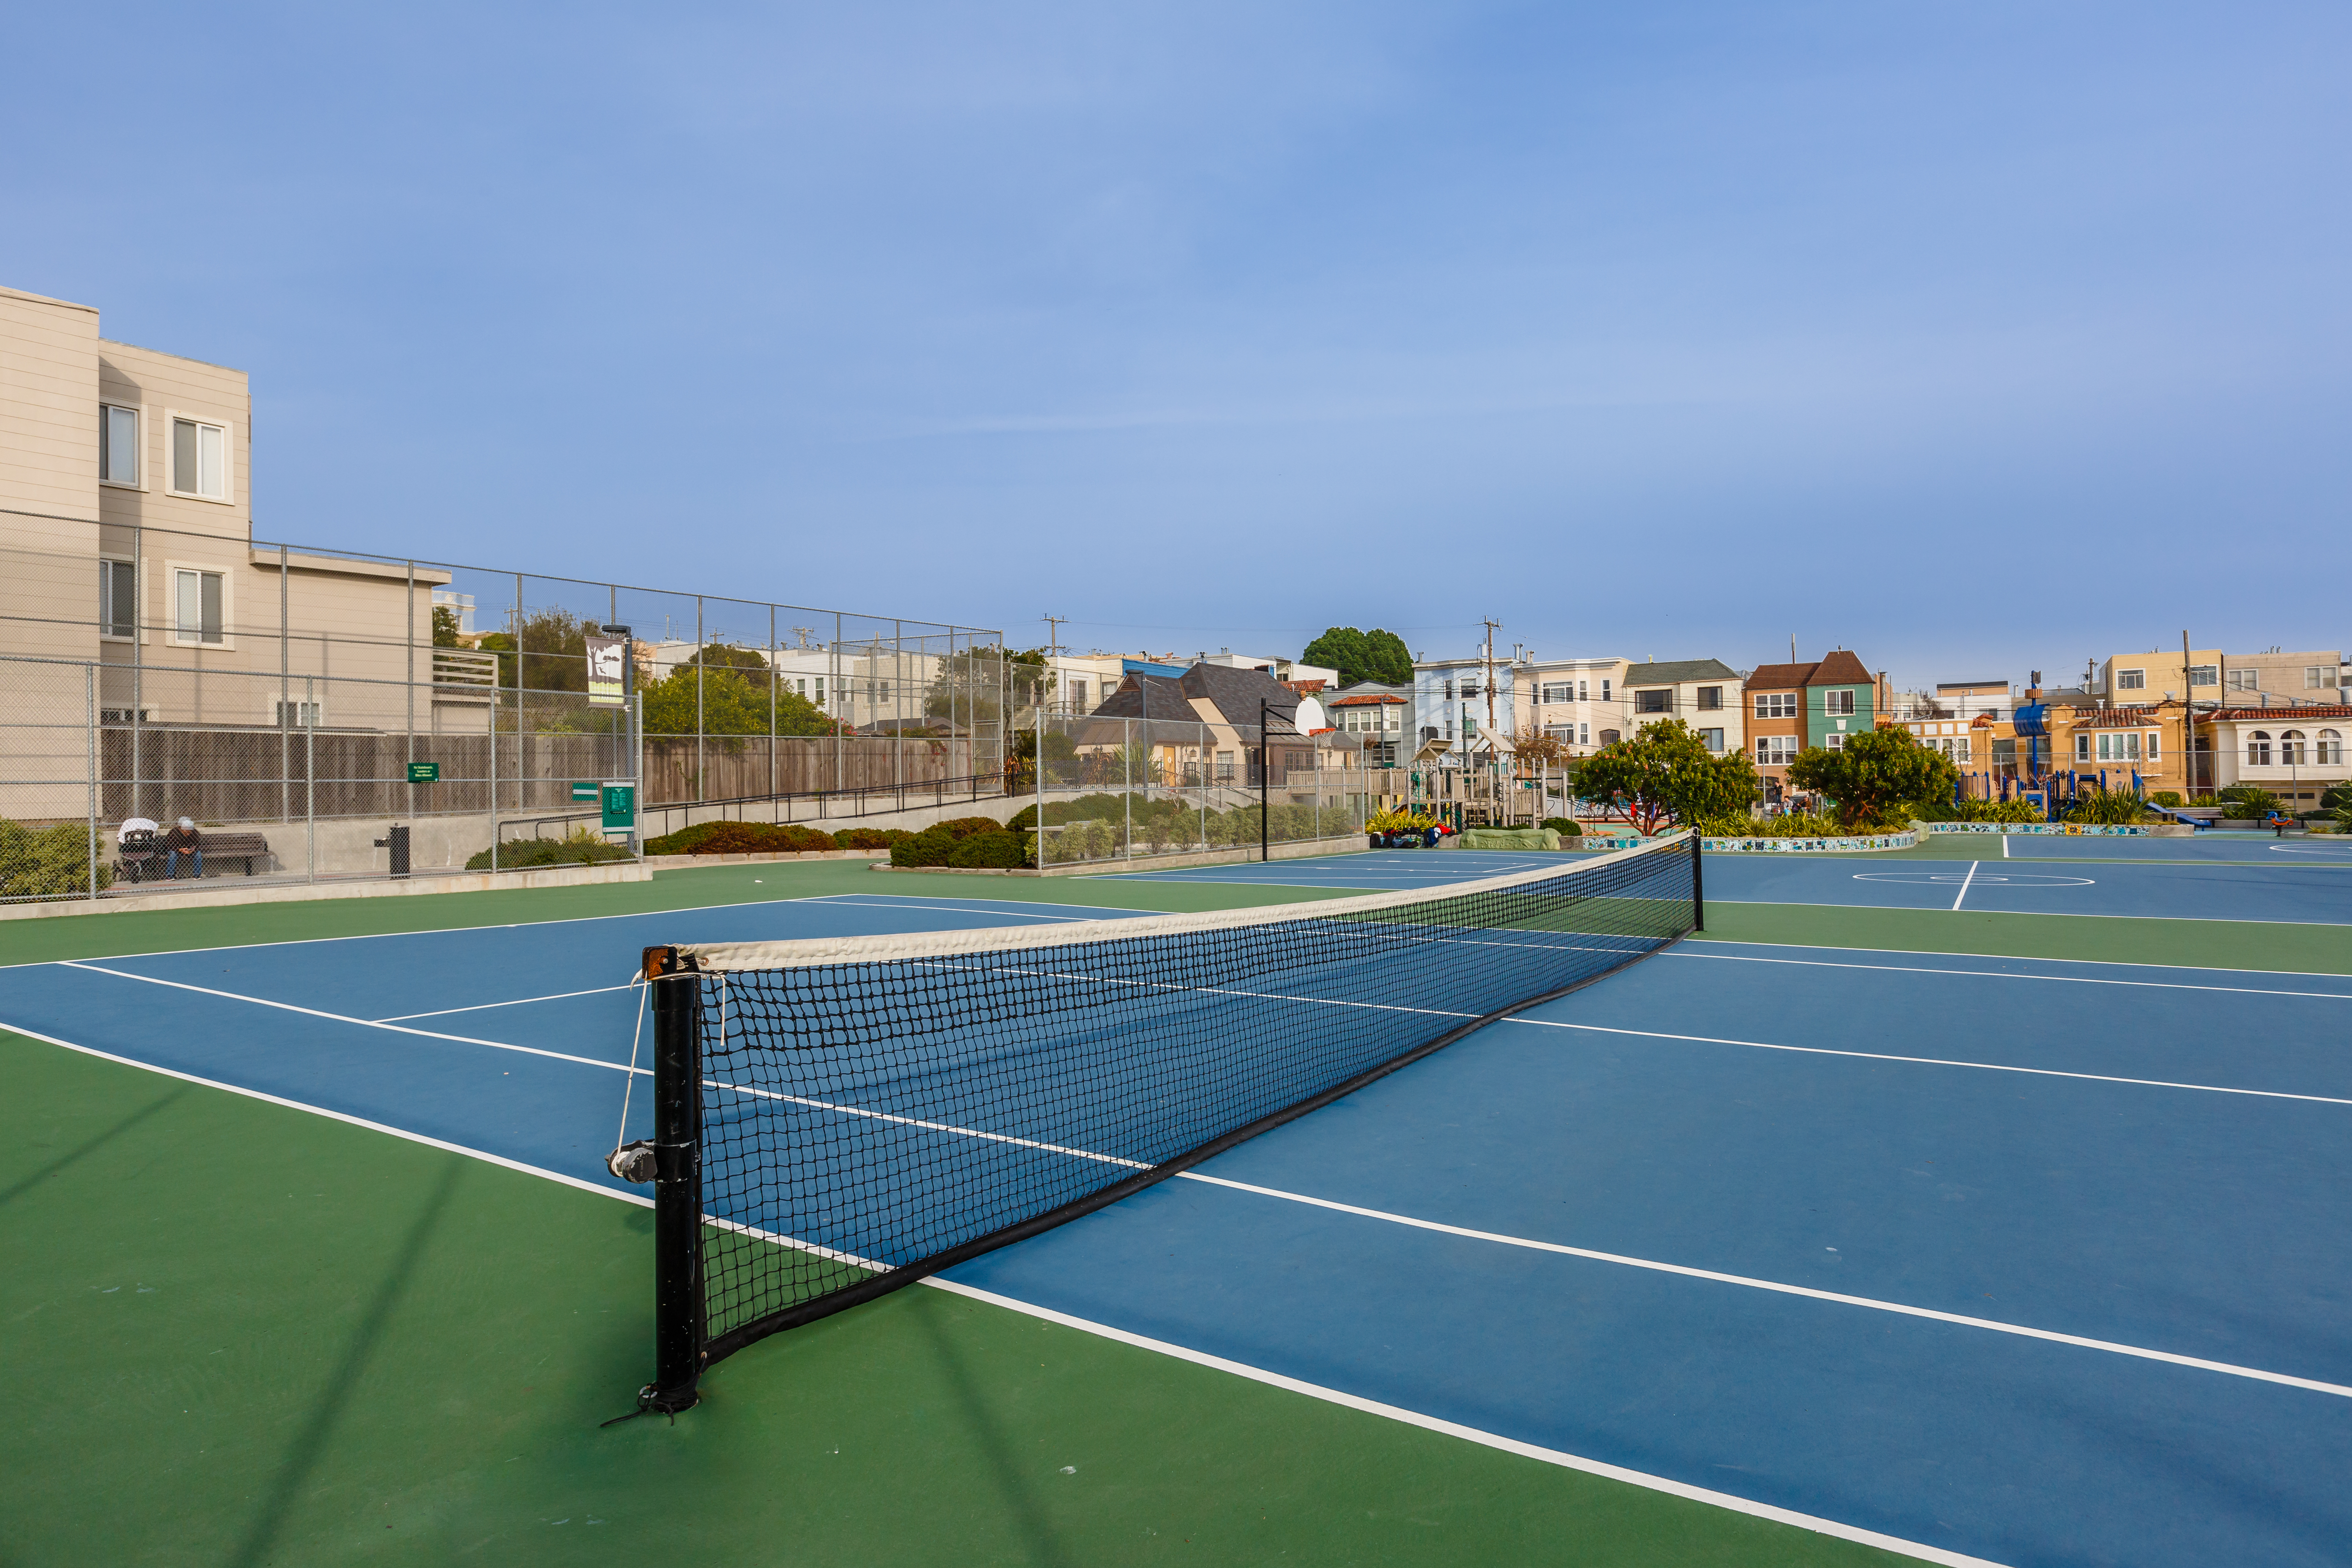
<box><xmin>0</xmin><ymin>839</ymin><xmax>2352</xmax><ymax>1563</ymax></box>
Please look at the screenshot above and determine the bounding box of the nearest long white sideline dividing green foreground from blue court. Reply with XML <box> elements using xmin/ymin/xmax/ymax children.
<box><xmin>0</xmin><ymin>1020</ymin><xmax>2002</xmax><ymax>1568</ymax></box>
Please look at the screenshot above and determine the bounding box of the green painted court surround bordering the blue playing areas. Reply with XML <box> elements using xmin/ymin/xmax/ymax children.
<box><xmin>0</xmin><ymin>863</ymin><xmax>2352</xmax><ymax>1566</ymax></box>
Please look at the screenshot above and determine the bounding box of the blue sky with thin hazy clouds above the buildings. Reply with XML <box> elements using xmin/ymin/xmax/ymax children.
<box><xmin>0</xmin><ymin>0</ymin><xmax>2352</xmax><ymax>682</ymax></box>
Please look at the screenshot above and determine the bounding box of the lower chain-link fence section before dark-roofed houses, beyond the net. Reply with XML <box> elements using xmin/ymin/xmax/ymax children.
<box><xmin>1011</xmin><ymin>717</ymin><xmax>1373</xmax><ymax>865</ymax></box>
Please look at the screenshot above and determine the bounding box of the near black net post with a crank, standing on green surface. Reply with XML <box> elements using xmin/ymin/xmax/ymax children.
<box><xmin>637</xmin><ymin>947</ymin><xmax>703</xmax><ymax>1415</ymax></box>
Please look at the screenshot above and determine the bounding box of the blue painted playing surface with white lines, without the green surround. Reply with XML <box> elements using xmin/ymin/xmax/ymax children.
<box><xmin>0</xmin><ymin>879</ymin><xmax>2352</xmax><ymax>1566</ymax></box>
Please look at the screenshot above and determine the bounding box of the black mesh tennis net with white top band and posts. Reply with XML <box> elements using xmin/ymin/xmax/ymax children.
<box><xmin>614</xmin><ymin>835</ymin><xmax>1703</xmax><ymax>1410</ymax></box>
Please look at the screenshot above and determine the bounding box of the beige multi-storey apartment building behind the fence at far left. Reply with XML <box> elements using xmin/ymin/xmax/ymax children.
<box><xmin>0</xmin><ymin>289</ymin><xmax>444</xmax><ymax>729</ymax></box>
